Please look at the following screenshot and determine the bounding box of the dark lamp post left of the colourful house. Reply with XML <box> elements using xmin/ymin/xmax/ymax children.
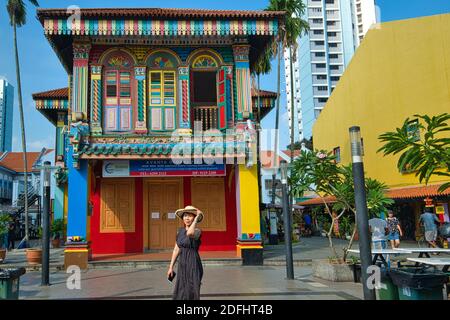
<box><xmin>41</xmin><ymin>161</ymin><xmax>51</xmax><ymax>286</ymax></box>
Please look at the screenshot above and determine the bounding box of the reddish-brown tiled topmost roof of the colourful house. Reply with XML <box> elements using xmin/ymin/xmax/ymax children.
<box><xmin>37</xmin><ymin>8</ymin><xmax>285</xmax><ymax>20</ymax></box>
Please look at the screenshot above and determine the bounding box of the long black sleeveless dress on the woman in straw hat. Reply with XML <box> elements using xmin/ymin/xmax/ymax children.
<box><xmin>172</xmin><ymin>228</ymin><xmax>203</xmax><ymax>300</ymax></box>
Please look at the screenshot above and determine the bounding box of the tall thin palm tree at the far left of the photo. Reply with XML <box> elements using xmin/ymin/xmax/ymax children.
<box><xmin>6</xmin><ymin>0</ymin><xmax>39</xmax><ymax>246</ymax></box>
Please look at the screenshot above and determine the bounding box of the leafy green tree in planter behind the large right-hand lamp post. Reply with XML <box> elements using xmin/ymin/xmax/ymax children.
<box><xmin>289</xmin><ymin>150</ymin><xmax>393</xmax><ymax>262</ymax></box>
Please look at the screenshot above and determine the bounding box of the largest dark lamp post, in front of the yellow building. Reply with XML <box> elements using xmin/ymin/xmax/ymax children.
<box><xmin>349</xmin><ymin>126</ymin><xmax>376</xmax><ymax>300</ymax></box>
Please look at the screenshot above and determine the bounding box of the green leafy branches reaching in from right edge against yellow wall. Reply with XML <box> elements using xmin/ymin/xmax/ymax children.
<box><xmin>378</xmin><ymin>113</ymin><xmax>450</xmax><ymax>192</ymax></box>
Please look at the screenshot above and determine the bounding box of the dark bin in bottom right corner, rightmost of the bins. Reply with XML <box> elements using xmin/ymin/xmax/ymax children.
<box><xmin>391</xmin><ymin>268</ymin><xmax>448</xmax><ymax>300</ymax></box>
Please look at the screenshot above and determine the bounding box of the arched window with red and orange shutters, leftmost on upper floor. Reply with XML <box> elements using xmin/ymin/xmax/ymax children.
<box><xmin>102</xmin><ymin>50</ymin><xmax>134</xmax><ymax>133</ymax></box>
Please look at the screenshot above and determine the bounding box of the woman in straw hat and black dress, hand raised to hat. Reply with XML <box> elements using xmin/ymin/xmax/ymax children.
<box><xmin>167</xmin><ymin>206</ymin><xmax>203</xmax><ymax>300</ymax></box>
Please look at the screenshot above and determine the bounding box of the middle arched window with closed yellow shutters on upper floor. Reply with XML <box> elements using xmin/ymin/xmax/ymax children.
<box><xmin>147</xmin><ymin>50</ymin><xmax>180</xmax><ymax>131</ymax></box>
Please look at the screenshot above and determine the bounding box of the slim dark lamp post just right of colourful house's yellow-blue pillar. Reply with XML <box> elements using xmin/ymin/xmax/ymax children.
<box><xmin>280</xmin><ymin>160</ymin><xmax>294</xmax><ymax>280</ymax></box>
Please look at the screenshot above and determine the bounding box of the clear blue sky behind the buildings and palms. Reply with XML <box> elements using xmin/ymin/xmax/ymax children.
<box><xmin>0</xmin><ymin>0</ymin><xmax>450</xmax><ymax>151</ymax></box>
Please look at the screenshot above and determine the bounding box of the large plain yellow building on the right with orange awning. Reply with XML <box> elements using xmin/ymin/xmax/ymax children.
<box><xmin>313</xmin><ymin>14</ymin><xmax>450</xmax><ymax>238</ymax></box>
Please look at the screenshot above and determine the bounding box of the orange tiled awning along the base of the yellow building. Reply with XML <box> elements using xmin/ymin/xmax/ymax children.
<box><xmin>300</xmin><ymin>184</ymin><xmax>450</xmax><ymax>206</ymax></box>
